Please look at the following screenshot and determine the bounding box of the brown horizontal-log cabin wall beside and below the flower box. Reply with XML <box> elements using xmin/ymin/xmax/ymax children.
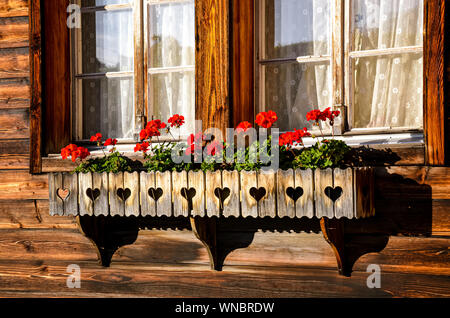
<box><xmin>0</xmin><ymin>0</ymin><xmax>450</xmax><ymax>297</ymax></box>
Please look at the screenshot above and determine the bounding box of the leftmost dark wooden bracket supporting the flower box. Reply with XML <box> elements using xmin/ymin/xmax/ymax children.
<box><xmin>77</xmin><ymin>216</ymin><xmax>139</xmax><ymax>267</ymax></box>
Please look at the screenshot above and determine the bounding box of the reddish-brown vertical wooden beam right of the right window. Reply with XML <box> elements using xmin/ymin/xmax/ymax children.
<box><xmin>424</xmin><ymin>0</ymin><xmax>449</xmax><ymax>166</ymax></box>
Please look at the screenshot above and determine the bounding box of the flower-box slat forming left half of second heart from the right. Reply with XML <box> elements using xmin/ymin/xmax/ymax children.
<box><xmin>277</xmin><ymin>169</ymin><xmax>295</xmax><ymax>218</ymax></box>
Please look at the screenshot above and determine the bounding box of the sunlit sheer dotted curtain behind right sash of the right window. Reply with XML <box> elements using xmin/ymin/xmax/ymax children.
<box><xmin>352</xmin><ymin>0</ymin><xmax>423</xmax><ymax>128</ymax></box>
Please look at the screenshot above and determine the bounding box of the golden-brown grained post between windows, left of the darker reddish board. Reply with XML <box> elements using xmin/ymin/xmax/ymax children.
<box><xmin>195</xmin><ymin>0</ymin><xmax>230</xmax><ymax>133</ymax></box>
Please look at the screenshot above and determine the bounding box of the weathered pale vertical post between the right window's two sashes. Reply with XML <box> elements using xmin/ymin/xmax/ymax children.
<box><xmin>331</xmin><ymin>0</ymin><xmax>348</xmax><ymax>135</ymax></box>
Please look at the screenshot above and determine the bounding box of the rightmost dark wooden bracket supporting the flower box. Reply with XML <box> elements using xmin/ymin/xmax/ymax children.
<box><xmin>320</xmin><ymin>218</ymin><xmax>389</xmax><ymax>277</ymax></box>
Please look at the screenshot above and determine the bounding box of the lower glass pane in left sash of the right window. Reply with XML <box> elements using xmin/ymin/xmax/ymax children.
<box><xmin>263</xmin><ymin>62</ymin><xmax>332</xmax><ymax>131</ymax></box>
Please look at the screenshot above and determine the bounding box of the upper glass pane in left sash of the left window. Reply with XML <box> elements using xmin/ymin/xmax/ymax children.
<box><xmin>78</xmin><ymin>10</ymin><xmax>134</xmax><ymax>73</ymax></box>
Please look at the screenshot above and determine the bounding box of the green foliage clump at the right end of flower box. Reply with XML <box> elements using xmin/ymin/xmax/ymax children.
<box><xmin>293</xmin><ymin>139</ymin><xmax>351</xmax><ymax>169</ymax></box>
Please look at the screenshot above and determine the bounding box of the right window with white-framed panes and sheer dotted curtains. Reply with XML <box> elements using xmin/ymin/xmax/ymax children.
<box><xmin>256</xmin><ymin>0</ymin><xmax>424</xmax><ymax>133</ymax></box>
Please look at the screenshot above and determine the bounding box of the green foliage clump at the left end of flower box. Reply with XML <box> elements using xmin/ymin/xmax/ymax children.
<box><xmin>75</xmin><ymin>151</ymin><xmax>133</xmax><ymax>173</ymax></box>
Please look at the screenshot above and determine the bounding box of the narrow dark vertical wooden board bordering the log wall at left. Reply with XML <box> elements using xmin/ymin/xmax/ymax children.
<box><xmin>29</xmin><ymin>0</ymin><xmax>42</xmax><ymax>173</ymax></box>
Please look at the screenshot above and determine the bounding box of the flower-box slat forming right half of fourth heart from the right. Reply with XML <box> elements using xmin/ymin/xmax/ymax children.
<box><xmin>222</xmin><ymin>171</ymin><xmax>241</xmax><ymax>217</ymax></box>
